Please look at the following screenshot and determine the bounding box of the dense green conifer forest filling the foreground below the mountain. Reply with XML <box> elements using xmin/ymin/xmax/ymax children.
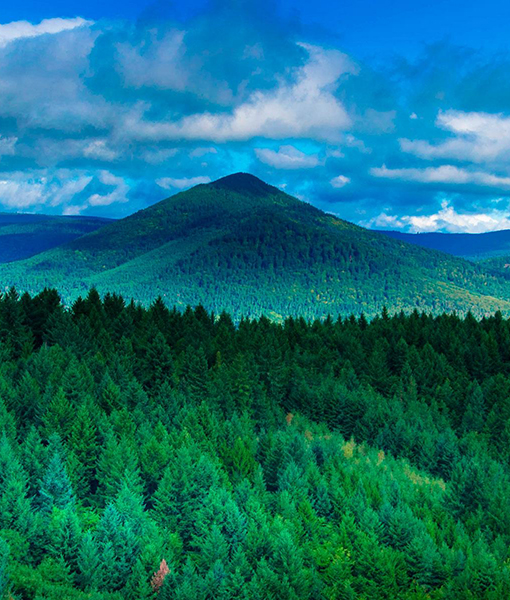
<box><xmin>0</xmin><ymin>289</ymin><xmax>510</xmax><ymax>600</ymax></box>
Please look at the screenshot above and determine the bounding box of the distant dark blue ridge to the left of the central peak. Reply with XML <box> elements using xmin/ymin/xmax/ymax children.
<box><xmin>0</xmin><ymin>214</ymin><xmax>111</xmax><ymax>263</ymax></box>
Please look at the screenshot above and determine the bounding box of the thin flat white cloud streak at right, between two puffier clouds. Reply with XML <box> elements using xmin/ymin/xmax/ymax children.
<box><xmin>370</xmin><ymin>165</ymin><xmax>510</xmax><ymax>188</ymax></box>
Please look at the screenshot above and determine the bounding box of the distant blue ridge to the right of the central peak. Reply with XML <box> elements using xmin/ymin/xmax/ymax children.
<box><xmin>379</xmin><ymin>229</ymin><xmax>510</xmax><ymax>261</ymax></box>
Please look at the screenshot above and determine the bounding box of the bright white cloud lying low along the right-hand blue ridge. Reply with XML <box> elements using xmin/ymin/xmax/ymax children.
<box><xmin>365</xmin><ymin>200</ymin><xmax>510</xmax><ymax>233</ymax></box>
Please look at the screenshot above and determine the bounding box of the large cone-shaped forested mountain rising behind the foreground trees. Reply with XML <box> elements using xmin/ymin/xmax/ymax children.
<box><xmin>0</xmin><ymin>173</ymin><xmax>510</xmax><ymax>319</ymax></box>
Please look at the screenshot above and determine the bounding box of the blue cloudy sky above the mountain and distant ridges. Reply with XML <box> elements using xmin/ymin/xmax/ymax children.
<box><xmin>0</xmin><ymin>0</ymin><xmax>510</xmax><ymax>232</ymax></box>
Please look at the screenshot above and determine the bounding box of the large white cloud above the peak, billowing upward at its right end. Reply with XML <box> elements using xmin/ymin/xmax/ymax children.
<box><xmin>123</xmin><ymin>44</ymin><xmax>355</xmax><ymax>142</ymax></box>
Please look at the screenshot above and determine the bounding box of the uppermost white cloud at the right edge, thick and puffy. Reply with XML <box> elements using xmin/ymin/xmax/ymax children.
<box><xmin>399</xmin><ymin>110</ymin><xmax>510</xmax><ymax>163</ymax></box>
